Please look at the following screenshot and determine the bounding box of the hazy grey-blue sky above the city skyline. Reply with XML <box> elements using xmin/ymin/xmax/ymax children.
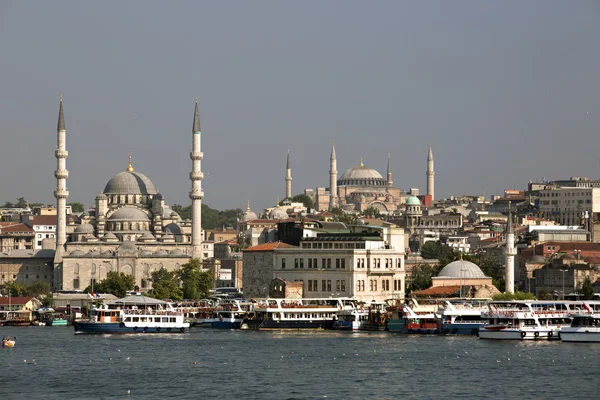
<box><xmin>0</xmin><ymin>0</ymin><xmax>600</xmax><ymax>210</ymax></box>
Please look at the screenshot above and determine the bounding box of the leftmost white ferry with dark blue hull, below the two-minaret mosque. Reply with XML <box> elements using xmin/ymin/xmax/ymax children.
<box><xmin>73</xmin><ymin>295</ymin><xmax>190</xmax><ymax>334</ymax></box>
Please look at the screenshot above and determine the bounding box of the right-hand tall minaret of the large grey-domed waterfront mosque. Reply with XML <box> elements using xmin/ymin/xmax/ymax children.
<box><xmin>190</xmin><ymin>97</ymin><xmax>204</xmax><ymax>260</ymax></box>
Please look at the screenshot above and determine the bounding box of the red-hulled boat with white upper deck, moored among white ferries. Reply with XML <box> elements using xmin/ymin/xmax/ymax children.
<box><xmin>387</xmin><ymin>298</ymin><xmax>441</xmax><ymax>335</ymax></box>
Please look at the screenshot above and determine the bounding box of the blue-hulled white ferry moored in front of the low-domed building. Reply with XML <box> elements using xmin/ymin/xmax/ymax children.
<box><xmin>438</xmin><ymin>298</ymin><xmax>490</xmax><ymax>336</ymax></box>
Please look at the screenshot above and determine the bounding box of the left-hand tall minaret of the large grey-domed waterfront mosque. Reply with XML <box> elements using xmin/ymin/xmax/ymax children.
<box><xmin>54</xmin><ymin>94</ymin><xmax>69</xmax><ymax>264</ymax></box>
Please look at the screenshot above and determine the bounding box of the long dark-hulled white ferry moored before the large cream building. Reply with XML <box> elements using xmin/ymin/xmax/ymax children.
<box><xmin>242</xmin><ymin>298</ymin><xmax>354</xmax><ymax>330</ymax></box>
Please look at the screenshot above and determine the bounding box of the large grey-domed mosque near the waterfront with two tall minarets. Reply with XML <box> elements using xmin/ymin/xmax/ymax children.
<box><xmin>54</xmin><ymin>98</ymin><xmax>204</xmax><ymax>291</ymax></box>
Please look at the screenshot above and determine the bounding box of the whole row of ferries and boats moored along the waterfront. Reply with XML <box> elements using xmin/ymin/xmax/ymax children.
<box><xmin>74</xmin><ymin>295</ymin><xmax>600</xmax><ymax>342</ymax></box>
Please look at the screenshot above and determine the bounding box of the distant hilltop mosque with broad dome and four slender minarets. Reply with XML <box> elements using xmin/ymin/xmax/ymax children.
<box><xmin>300</xmin><ymin>145</ymin><xmax>435</xmax><ymax>214</ymax></box>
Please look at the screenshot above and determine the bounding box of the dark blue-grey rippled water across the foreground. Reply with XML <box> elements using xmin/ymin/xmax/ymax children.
<box><xmin>0</xmin><ymin>327</ymin><xmax>600</xmax><ymax>400</ymax></box>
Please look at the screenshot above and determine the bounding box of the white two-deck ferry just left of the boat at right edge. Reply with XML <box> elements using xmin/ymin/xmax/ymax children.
<box><xmin>478</xmin><ymin>300</ymin><xmax>582</xmax><ymax>340</ymax></box>
